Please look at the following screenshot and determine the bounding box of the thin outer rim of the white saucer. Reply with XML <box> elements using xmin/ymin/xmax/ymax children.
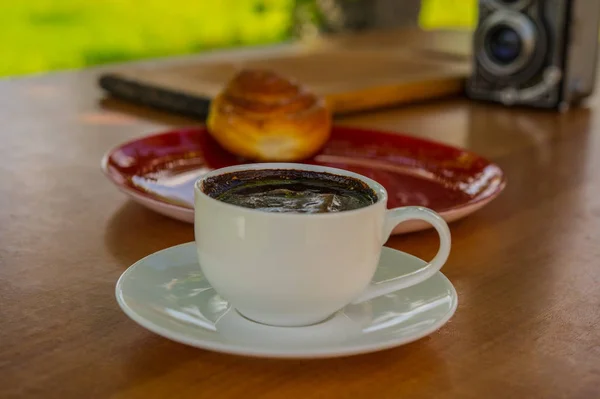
<box><xmin>115</xmin><ymin>241</ymin><xmax>458</xmax><ymax>359</ymax></box>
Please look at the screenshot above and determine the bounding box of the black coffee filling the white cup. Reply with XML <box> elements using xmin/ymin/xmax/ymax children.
<box><xmin>202</xmin><ymin>169</ymin><xmax>377</xmax><ymax>213</ymax></box>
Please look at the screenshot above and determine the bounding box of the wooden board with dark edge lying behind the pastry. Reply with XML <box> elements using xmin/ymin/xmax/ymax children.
<box><xmin>100</xmin><ymin>30</ymin><xmax>470</xmax><ymax>117</ymax></box>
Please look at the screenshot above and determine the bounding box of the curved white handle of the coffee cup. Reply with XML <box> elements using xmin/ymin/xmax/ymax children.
<box><xmin>352</xmin><ymin>206</ymin><xmax>451</xmax><ymax>304</ymax></box>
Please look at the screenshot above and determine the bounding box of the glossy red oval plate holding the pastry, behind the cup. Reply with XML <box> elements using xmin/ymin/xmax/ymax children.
<box><xmin>102</xmin><ymin>126</ymin><xmax>505</xmax><ymax>234</ymax></box>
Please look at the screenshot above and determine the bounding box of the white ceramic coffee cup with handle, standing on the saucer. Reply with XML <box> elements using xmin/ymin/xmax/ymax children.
<box><xmin>194</xmin><ymin>163</ymin><xmax>450</xmax><ymax>326</ymax></box>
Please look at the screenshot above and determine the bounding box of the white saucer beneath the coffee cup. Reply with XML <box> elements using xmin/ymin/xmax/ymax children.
<box><xmin>116</xmin><ymin>242</ymin><xmax>458</xmax><ymax>358</ymax></box>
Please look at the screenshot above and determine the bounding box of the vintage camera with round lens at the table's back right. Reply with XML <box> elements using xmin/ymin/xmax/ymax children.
<box><xmin>466</xmin><ymin>0</ymin><xmax>600</xmax><ymax>110</ymax></box>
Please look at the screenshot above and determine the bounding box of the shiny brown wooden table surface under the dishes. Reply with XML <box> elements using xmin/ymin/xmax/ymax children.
<box><xmin>0</xmin><ymin>32</ymin><xmax>600</xmax><ymax>399</ymax></box>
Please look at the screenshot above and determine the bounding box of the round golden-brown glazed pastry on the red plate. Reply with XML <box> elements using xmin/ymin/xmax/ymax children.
<box><xmin>207</xmin><ymin>70</ymin><xmax>331</xmax><ymax>162</ymax></box>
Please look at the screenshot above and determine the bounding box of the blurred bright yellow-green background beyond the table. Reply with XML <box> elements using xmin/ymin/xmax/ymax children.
<box><xmin>0</xmin><ymin>0</ymin><xmax>477</xmax><ymax>76</ymax></box>
